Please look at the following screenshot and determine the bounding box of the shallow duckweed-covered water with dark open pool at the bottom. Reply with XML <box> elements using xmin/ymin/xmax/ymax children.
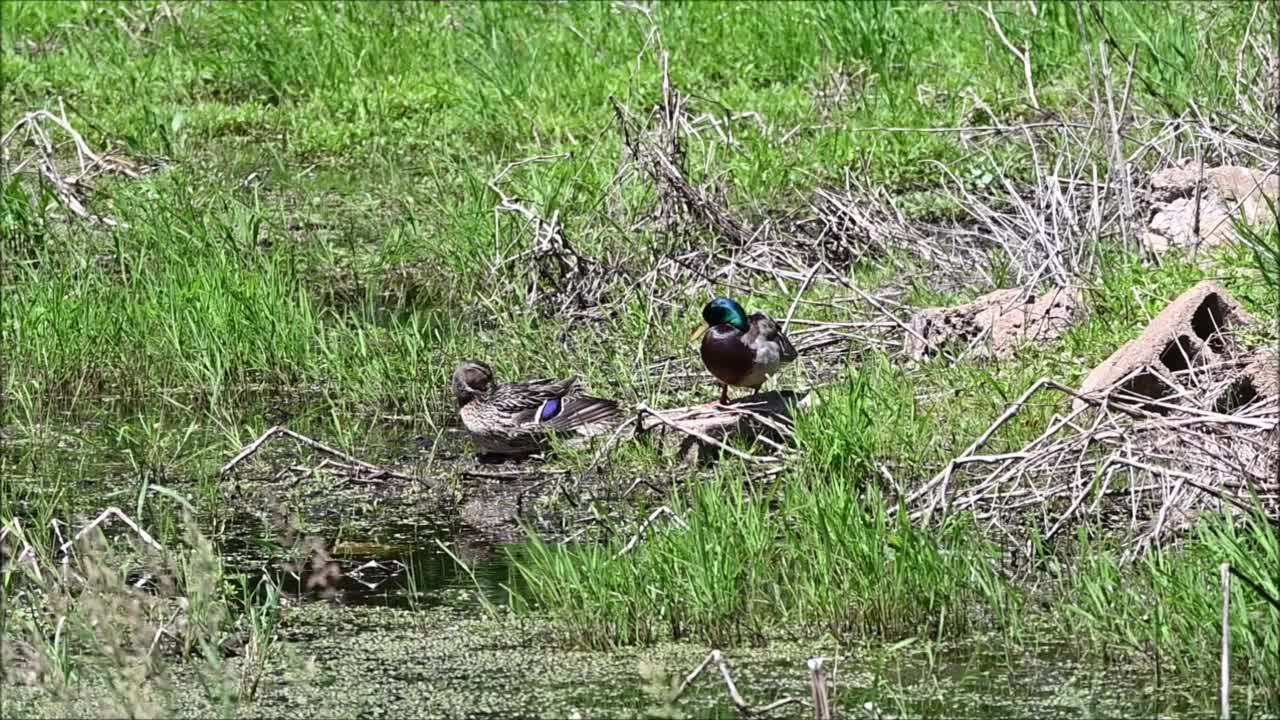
<box><xmin>202</xmin><ymin>520</ymin><xmax>1216</xmax><ymax>717</ymax></box>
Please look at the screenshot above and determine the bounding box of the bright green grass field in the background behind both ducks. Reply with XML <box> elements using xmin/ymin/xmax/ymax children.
<box><xmin>0</xmin><ymin>3</ymin><xmax>1274</xmax><ymax>404</ymax></box>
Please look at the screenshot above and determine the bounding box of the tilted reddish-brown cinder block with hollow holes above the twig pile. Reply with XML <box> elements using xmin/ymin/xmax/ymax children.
<box><xmin>1075</xmin><ymin>281</ymin><xmax>1252</xmax><ymax>410</ymax></box>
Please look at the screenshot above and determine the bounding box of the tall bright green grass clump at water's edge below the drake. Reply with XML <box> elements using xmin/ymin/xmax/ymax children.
<box><xmin>512</xmin><ymin>473</ymin><xmax>1018</xmax><ymax>646</ymax></box>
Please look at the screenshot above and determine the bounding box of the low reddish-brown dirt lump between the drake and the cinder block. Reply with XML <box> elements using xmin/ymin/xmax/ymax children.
<box><xmin>904</xmin><ymin>287</ymin><xmax>1080</xmax><ymax>360</ymax></box>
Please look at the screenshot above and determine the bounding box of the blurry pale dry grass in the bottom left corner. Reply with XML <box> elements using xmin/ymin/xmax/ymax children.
<box><xmin>3</xmin><ymin>507</ymin><xmax>280</xmax><ymax>717</ymax></box>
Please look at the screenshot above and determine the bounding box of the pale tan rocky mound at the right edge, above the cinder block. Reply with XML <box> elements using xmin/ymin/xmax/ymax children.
<box><xmin>1142</xmin><ymin>163</ymin><xmax>1280</xmax><ymax>254</ymax></box>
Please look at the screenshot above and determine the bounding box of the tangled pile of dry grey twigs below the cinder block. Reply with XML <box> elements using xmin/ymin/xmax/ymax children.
<box><xmin>906</xmin><ymin>363</ymin><xmax>1280</xmax><ymax>552</ymax></box>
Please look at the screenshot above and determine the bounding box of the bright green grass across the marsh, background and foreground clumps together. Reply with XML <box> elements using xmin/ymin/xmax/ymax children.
<box><xmin>0</xmin><ymin>1</ymin><xmax>1280</xmax><ymax>712</ymax></box>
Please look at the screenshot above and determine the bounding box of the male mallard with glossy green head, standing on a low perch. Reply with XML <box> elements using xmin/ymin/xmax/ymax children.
<box><xmin>690</xmin><ymin>297</ymin><xmax>796</xmax><ymax>404</ymax></box>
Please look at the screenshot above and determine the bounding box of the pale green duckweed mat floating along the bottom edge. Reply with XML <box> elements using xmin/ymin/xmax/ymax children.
<box><xmin>5</xmin><ymin>605</ymin><xmax>1218</xmax><ymax>719</ymax></box>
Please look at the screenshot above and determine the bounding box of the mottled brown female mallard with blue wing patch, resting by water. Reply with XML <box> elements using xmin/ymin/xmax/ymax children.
<box><xmin>453</xmin><ymin>360</ymin><xmax>618</xmax><ymax>455</ymax></box>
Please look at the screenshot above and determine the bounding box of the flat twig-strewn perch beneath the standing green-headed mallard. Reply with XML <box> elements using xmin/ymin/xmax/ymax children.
<box><xmin>637</xmin><ymin>389</ymin><xmax>818</xmax><ymax>465</ymax></box>
